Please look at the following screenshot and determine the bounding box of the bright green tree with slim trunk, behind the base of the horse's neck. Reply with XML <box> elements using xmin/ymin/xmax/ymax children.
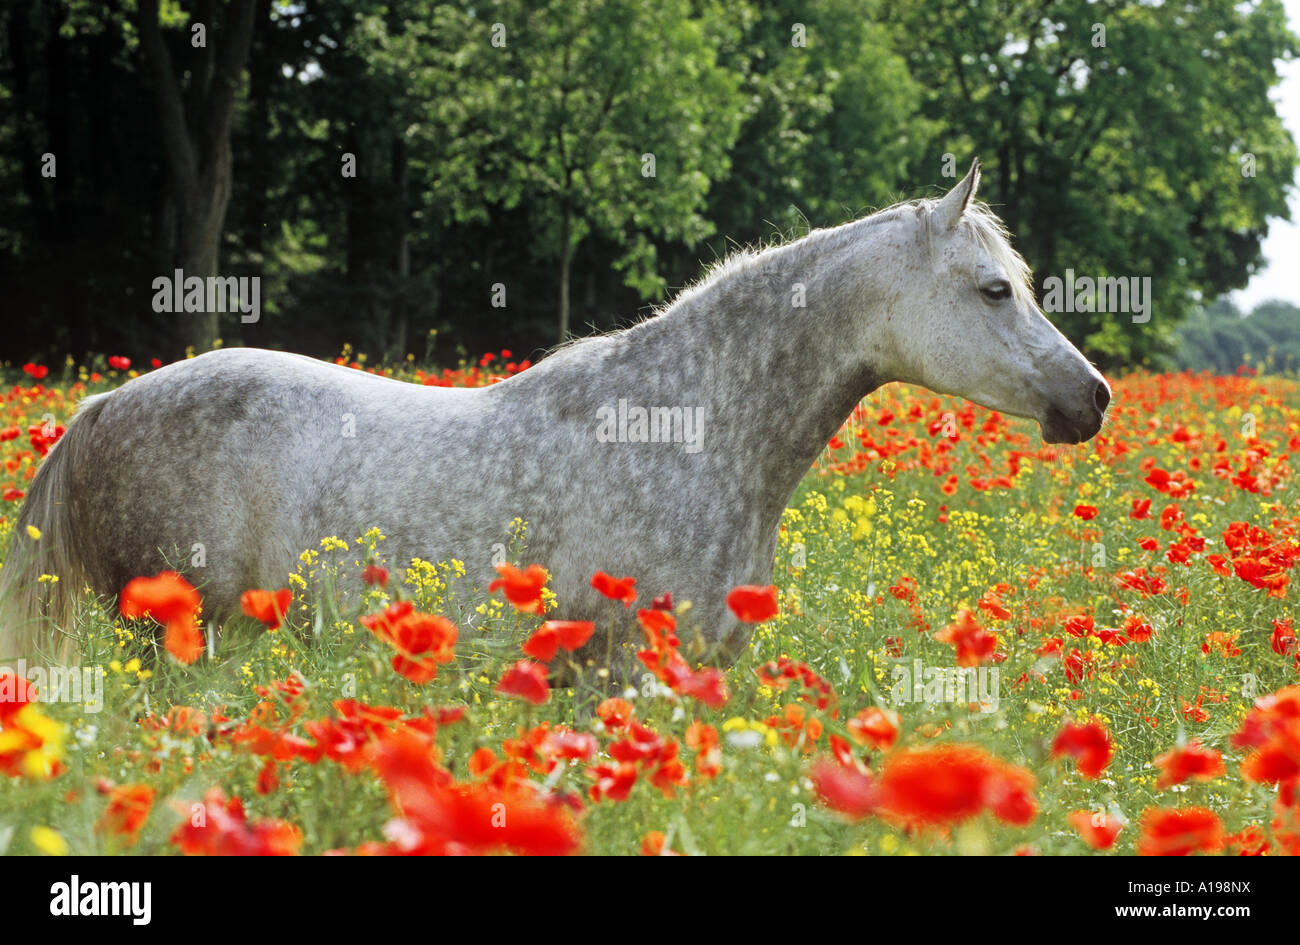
<box><xmin>478</xmin><ymin>0</ymin><xmax>740</xmax><ymax>339</ymax></box>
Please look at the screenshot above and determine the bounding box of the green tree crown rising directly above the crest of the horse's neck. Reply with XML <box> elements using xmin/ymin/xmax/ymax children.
<box><xmin>709</xmin><ymin>0</ymin><xmax>933</xmax><ymax>255</ymax></box>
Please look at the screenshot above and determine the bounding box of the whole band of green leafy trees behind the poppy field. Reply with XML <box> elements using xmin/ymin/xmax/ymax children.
<box><xmin>0</xmin><ymin>0</ymin><xmax>1296</xmax><ymax>365</ymax></box>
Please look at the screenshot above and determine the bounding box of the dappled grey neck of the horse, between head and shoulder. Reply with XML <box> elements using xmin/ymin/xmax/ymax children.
<box><xmin>618</xmin><ymin>221</ymin><xmax>888</xmax><ymax>525</ymax></box>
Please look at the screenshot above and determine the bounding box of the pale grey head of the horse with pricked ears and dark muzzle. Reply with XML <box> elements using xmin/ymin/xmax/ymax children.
<box><xmin>889</xmin><ymin>161</ymin><xmax>1110</xmax><ymax>443</ymax></box>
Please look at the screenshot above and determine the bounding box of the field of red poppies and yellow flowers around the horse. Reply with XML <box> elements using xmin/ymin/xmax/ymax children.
<box><xmin>0</xmin><ymin>352</ymin><xmax>1300</xmax><ymax>855</ymax></box>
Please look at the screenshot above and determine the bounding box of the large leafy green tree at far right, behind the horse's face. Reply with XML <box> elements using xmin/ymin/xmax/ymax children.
<box><xmin>889</xmin><ymin>0</ymin><xmax>1297</xmax><ymax>364</ymax></box>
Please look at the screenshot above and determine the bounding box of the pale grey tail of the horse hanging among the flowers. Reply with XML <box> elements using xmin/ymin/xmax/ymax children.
<box><xmin>0</xmin><ymin>394</ymin><xmax>108</xmax><ymax>662</ymax></box>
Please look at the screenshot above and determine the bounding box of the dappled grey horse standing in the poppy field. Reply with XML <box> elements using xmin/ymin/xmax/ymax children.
<box><xmin>0</xmin><ymin>161</ymin><xmax>1110</xmax><ymax>668</ymax></box>
